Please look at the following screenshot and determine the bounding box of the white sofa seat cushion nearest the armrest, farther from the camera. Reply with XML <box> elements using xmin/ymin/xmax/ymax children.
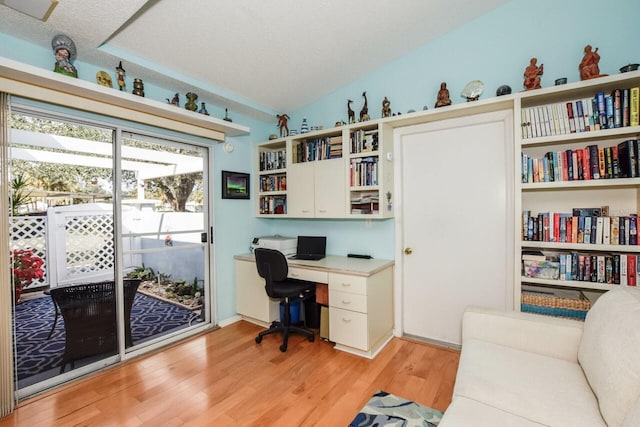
<box><xmin>454</xmin><ymin>340</ymin><xmax>605</xmax><ymax>427</ymax></box>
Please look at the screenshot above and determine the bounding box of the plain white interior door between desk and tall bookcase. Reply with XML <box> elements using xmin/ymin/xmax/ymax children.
<box><xmin>395</xmin><ymin>111</ymin><xmax>514</xmax><ymax>345</ymax></box>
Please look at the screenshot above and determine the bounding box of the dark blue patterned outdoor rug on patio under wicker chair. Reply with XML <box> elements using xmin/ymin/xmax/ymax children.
<box><xmin>14</xmin><ymin>292</ymin><xmax>198</xmax><ymax>381</ymax></box>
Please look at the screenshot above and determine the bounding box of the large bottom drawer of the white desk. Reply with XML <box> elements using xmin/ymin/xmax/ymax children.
<box><xmin>329</xmin><ymin>307</ymin><xmax>369</xmax><ymax>351</ymax></box>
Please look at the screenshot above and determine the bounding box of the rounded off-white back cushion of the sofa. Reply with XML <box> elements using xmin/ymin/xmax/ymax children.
<box><xmin>578</xmin><ymin>287</ymin><xmax>640</xmax><ymax>427</ymax></box>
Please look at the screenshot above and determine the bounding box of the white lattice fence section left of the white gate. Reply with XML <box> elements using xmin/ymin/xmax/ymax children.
<box><xmin>9</xmin><ymin>216</ymin><xmax>49</xmax><ymax>288</ymax></box>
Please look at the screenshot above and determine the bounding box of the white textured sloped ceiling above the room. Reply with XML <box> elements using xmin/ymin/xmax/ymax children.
<box><xmin>0</xmin><ymin>0</ymin><xmax>508</xmax><ymax>120</ymax></box>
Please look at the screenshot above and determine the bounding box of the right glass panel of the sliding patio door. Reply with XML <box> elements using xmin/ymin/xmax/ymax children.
<box><xmin>120</xmin><ymin>132</ymin><xmax>209</xmax><ymax>352</ymax></box>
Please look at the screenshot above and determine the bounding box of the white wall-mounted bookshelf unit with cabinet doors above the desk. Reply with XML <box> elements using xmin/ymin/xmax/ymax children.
<box><xmin>256</xmin><ymin>120</ymin><xmax>393</xmax><ymax>219</ymax></box>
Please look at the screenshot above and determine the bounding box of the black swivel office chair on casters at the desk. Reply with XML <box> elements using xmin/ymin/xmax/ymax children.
<box><xmin>254</xmin><ymin>248</ymin><xmax>316</xmax><ymax>352</ymax></box>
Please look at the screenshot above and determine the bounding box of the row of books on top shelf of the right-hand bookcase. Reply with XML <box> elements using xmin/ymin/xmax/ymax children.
<box><xmin>521</xmin><ymin>87</ymin><xmax>640</xmax><ymax>139</ymax></box>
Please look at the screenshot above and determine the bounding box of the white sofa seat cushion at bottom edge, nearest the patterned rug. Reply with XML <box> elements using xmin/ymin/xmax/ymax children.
<box><xmin>438</xmin><ymin>396</ymin><xmax>543</xmax><ymax>427</ymax></box>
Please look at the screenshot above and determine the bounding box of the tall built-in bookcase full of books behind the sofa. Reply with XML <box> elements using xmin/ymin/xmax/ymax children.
<box><xmin>515</xmin><ymin>69</ymin><xmax>640</xmax><ymax>310</ymax></box>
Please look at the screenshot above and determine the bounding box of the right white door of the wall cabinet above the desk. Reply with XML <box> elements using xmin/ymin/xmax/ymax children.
<box><xmin>315</xmin><ymin>158</ymin><xmax>347</xmax><ymax>218</ymax></box>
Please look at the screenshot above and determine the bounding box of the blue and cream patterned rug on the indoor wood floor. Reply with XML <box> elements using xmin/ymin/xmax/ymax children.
<box><xmin>349</xmin><ymin>390</ymin><xmax>442</xmax><ymax>427</ymax></box>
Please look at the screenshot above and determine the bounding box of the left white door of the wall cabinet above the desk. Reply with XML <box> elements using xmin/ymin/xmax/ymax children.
<box><xmin>287</xmin><ymin>162</ymin><xmax>315</xmax><ymax>218</ymax></box>
